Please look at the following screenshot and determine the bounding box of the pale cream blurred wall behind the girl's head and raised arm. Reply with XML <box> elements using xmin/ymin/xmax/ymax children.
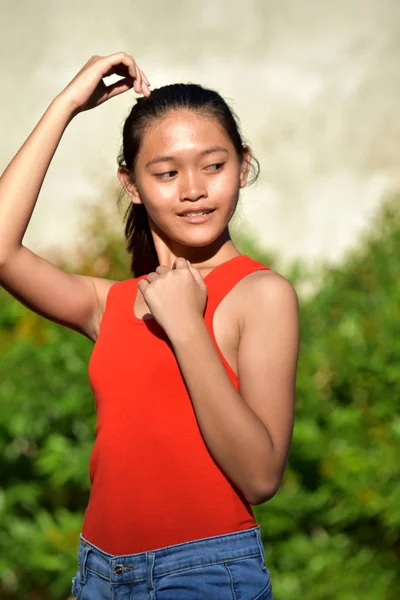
<box><xmin>0</xmin><ymin>0</ymin><xmax>400</xmax><ymax>268</ymax></box>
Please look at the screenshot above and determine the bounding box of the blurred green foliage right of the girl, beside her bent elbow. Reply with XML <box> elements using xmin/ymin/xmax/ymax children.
<box><xmin>256</xmin><ymin>198</ymin><xmax>400</xmax><ymax>600</ymax></box>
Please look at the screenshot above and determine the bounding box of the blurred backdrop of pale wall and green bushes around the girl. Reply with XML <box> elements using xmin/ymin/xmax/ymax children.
<box><xmin>0</xmin><ymin>0</ymin><xmax>400</xmax><ymax>600</ymax></box>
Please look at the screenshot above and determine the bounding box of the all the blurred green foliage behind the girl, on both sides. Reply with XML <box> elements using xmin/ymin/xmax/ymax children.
<box><xmin>0</xmin><ymin>191</ymin><xmax>400</xmax><ymax>600</ymax></box>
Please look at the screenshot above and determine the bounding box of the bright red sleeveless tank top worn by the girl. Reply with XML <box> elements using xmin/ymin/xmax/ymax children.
<box><xmin>82</xmin><ymin>254</ymin><xmax>270</xmax><ymax>555</ymax></box>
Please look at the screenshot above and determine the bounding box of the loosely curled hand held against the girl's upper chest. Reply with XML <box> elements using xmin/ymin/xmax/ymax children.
<box><xmin>138</xmin><ymin>257</ymin><xmax>207</xmax><ymax>335</ymax></box>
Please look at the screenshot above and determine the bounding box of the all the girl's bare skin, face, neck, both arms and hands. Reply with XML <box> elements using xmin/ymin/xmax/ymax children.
<box><xmin>0</xmin><ymin>47</ymin><xmax>299</xmax><ymax>504</ymax></box>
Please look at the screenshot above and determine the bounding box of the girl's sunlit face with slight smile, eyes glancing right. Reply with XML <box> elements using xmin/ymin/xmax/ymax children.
<box><xmin>119</xmin><ymin>109</ymin><xmax>250</xmax><ymax>257</ymax></box>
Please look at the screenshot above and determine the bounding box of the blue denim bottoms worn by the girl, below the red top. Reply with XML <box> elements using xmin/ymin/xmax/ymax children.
<box><xmin>72</xmin><ymin>525</ymin><xmax>273</xmax><ymax>600</ymax></box>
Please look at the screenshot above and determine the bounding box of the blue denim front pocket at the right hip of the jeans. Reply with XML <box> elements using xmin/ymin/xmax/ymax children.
<box><xmin>225</xmin><ymin>554</ymin><xmax>272</xmax><ymax>600</ymax></box>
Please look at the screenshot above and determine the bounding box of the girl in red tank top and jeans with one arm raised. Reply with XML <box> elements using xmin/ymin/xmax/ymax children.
<box><xmin>0</xmin><ymin>52</ymin><xmax>299</xmax><ymax>600</ymax></box>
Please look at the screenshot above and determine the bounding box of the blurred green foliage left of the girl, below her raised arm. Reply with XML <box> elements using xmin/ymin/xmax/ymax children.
<box><xmin>0</xmin><ymin>314</ymin><xmax>95</xmax><ymax>598</ymax></box>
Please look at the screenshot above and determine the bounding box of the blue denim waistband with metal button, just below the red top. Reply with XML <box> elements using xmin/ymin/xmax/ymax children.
<box><xmin>78</xmin><ymin>525</ymin><xmax>264</xmax><ymax>583</ymax></box>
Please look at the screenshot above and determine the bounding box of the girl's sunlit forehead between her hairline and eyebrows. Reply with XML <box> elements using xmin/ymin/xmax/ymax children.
<box><xmin>140</xmin><ymin>109</ymin><xmax>233</xmax><ymax>159</ymax></box>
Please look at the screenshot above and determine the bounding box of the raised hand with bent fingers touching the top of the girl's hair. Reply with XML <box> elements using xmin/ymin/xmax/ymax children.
<box><xmin>59</xmin><ymin>52</ymin><xmax>150</xmax><ymax>113</ymax></box>
